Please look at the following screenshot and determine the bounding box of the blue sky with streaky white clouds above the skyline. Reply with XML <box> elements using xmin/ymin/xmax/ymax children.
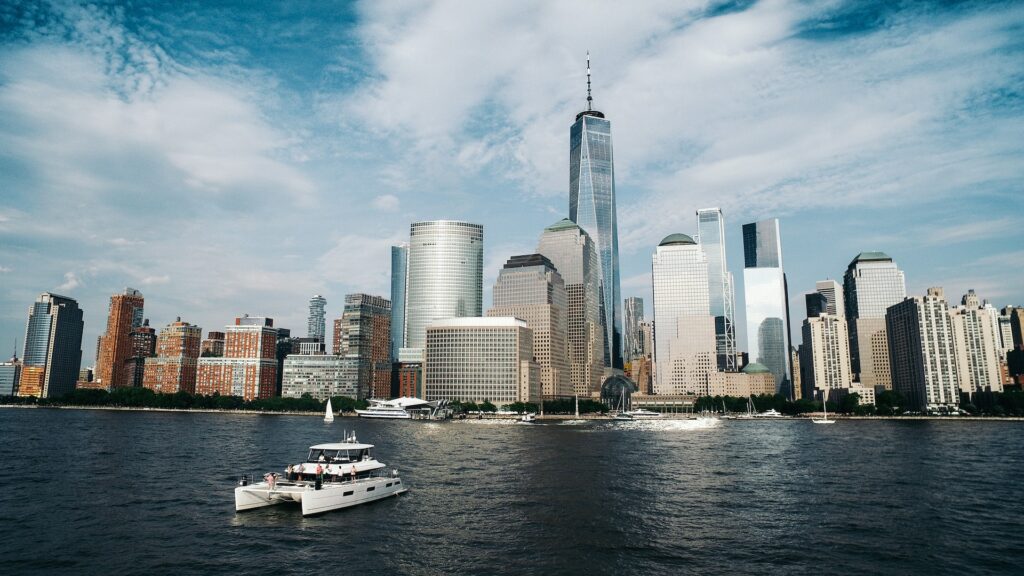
<box><xmin>0</xmin><ymin>0</ymin><xmax>1024</xmax><ymax>366</ymax></box>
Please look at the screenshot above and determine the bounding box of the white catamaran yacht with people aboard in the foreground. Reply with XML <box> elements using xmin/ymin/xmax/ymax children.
<box><xmin>234</xmin><ymin>435</ymin><xmax>407</xmax><ymax>516</ymax></box>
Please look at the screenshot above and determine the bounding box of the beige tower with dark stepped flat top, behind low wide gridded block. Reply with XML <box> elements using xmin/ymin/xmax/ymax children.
<box><xmin>487</xmin><ymin>254</ymin><xmax>572</xmax><ymax>397</ymax></box>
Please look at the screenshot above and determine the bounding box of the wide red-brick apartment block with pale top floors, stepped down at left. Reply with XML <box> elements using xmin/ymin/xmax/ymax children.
<box><xmin>196</xmin><ymin>315</ymin><xmax>278</xmax><ymax>400</ymax></box>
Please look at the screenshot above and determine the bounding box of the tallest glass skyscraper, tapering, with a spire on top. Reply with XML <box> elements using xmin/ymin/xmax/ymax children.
<box><xmin>569</xmin><ymin>54</ymin><xmax>623</xmax><ymax>369</ymax></box>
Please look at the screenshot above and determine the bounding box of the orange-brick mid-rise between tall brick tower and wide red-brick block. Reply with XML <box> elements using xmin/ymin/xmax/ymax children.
<box><xmin>142</xmin><ymin>317</ymin><xmax>202</xmax><ymax>394</ymax></box>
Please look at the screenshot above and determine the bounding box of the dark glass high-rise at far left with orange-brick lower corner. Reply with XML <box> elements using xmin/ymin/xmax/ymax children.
<box><xmin>17</xmin><ymin>292</ymin><xmax>83</xmax><ymax>398</ymax></box>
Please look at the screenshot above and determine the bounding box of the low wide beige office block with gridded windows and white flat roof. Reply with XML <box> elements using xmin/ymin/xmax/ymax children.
<box><xmin>423</xmin><ymin>318</ymin><xmax>541</xmax><ymax>407</ymax></box>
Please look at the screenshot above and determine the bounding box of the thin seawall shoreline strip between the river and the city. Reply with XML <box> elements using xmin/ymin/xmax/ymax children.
<box><xmin>0</xmin><ymin>404</ymin><xmax>1024</xmax><ymax>422</ymax></box>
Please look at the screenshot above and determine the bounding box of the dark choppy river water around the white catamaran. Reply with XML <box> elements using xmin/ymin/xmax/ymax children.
<box><xmin>0</xmin><ymin>409</ymin><xmax>1024</xmax><ymax>576</ymax></box>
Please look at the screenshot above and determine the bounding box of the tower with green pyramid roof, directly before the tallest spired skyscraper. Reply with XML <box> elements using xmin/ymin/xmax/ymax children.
<box><xmin>537</xmin><ymin>218</ymin><xmax>604</xmax><ymax>397</ymax></box>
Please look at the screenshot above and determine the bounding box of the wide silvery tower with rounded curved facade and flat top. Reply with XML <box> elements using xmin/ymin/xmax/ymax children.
<box><xmin>403</xmin><ymin>220</ymin><xmax>483</xmax><ymax>358</ymax></box>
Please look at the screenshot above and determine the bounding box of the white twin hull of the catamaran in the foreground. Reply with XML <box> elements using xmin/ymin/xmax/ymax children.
<box><xmin>234</xmin><ymin>477</ymin><xmax>407</xmax><ymax>516</ymax></box>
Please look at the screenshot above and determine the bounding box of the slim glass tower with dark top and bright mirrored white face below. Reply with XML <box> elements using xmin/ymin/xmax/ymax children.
<box><xmin>743</xmin><ymin>218</ymin><xmax>794</xmax><ymax>398</ymax></box>
